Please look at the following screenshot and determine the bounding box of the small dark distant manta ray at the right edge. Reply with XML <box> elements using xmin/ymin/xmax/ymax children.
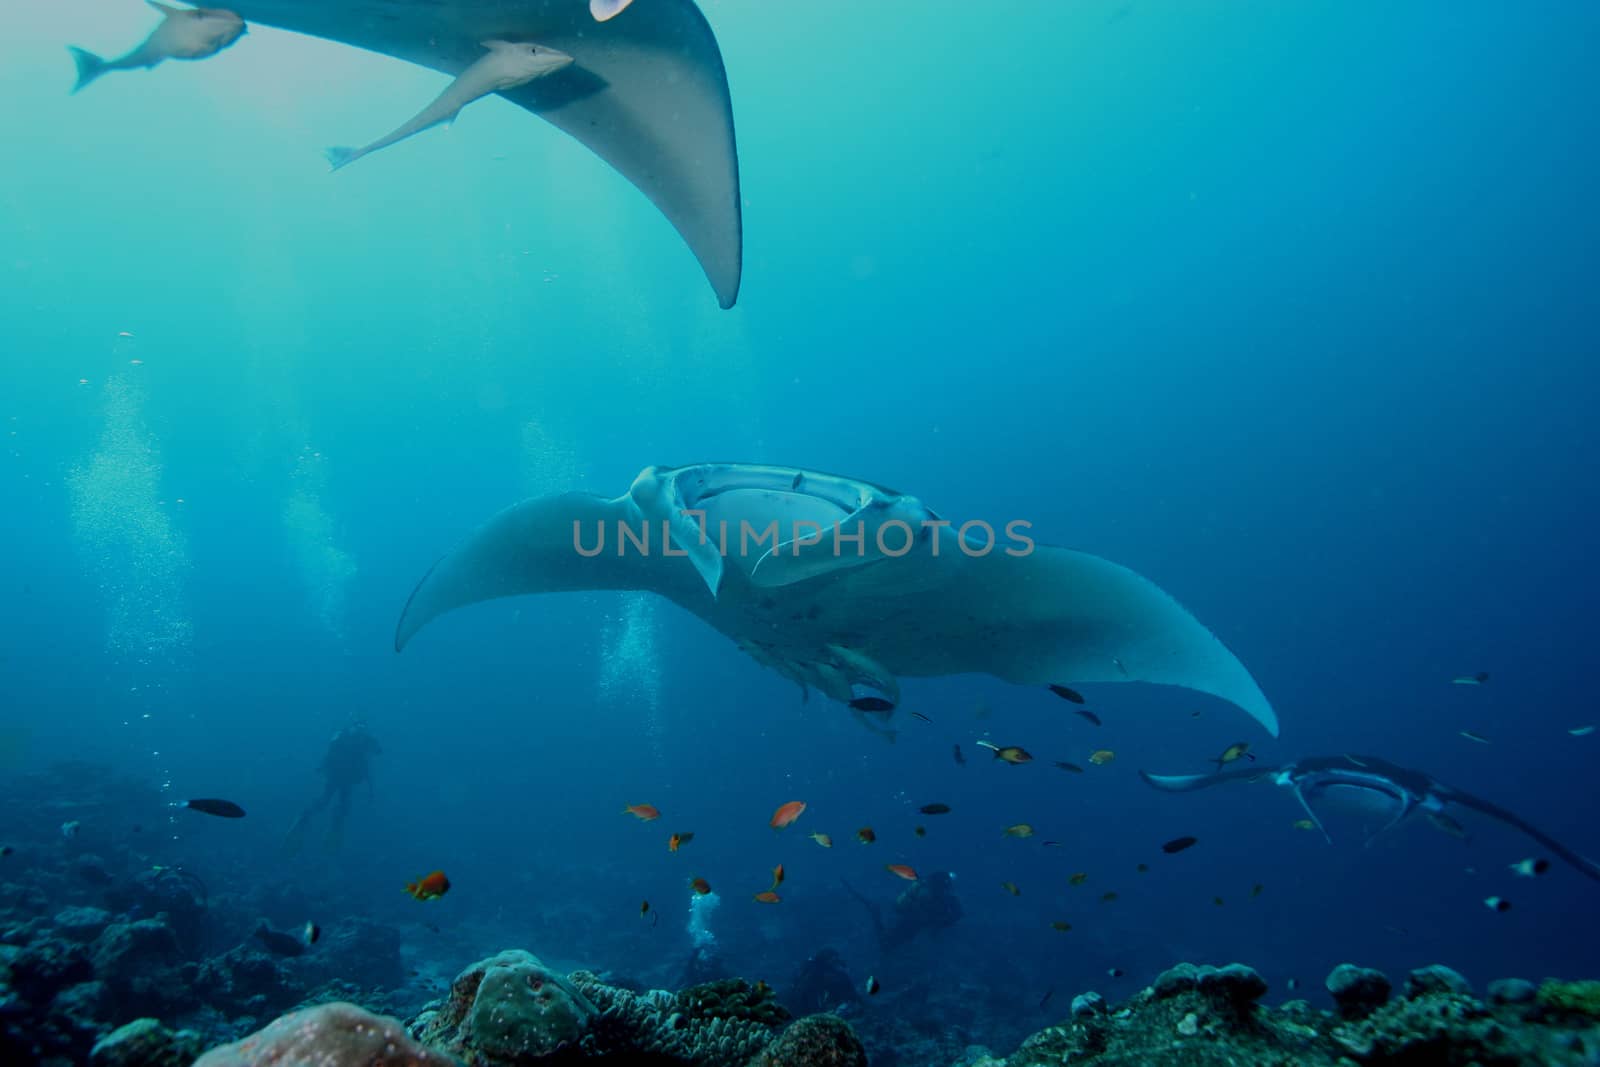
<box><xmin>1139</xmin><ymin>755</ymin><xmax>1600</xmax><ymax>881</ymax></box>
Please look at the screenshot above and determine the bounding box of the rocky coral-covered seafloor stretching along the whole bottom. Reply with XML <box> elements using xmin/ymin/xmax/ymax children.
<box><xmin>0</xmin><ymin>766</ymin><xmax>1600</xmax><ymax>1067</ymax></box>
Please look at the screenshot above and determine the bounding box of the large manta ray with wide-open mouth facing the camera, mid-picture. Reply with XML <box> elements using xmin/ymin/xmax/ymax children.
<box><xmin>395</xmin><ymin>464</ymin><xmax>1278</xmax><ymax>736</ymax></box>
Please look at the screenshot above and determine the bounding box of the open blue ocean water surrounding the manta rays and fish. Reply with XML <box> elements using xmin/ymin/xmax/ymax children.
<box><xmin>0</xmin><ymin>0</ymin><xmax>1600</xmax><ymax>1048</ymax></box>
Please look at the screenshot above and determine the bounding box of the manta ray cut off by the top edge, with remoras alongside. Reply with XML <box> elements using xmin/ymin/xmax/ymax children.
<box><xmin>227</xmin><ymin>0</ymin><xmax>742</xmax><ymax>307</ymax></box>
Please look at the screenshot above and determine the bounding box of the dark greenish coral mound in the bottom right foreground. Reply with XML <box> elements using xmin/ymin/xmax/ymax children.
<box><xmin>962</xmin><ymin>963</ymin><xmax>1600</xmax><ymax>1067</ymax></box>
